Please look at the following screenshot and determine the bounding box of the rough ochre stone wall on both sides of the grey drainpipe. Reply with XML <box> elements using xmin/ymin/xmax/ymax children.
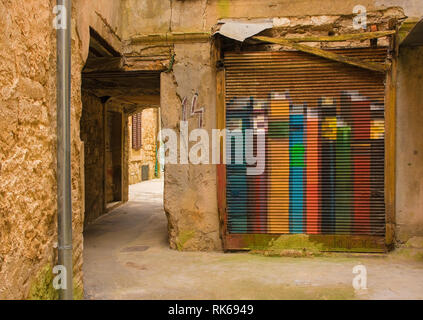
<box><xmin>0</xmin><ymin>0</ymin><xmax>121</xmax><ymax>299</ymax></box>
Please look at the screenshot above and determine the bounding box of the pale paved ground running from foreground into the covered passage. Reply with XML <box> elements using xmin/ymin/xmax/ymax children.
<box><xmin>84</xmin><ymin>180</ymin><xmax>423</xmax><ymax>299</ymax></box>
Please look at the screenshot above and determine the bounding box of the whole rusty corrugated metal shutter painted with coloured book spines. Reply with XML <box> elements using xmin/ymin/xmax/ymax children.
<box><xmin>224</xmin><ymin>48</ymin><xmax>387</xmax><ymax>236</ymax></box>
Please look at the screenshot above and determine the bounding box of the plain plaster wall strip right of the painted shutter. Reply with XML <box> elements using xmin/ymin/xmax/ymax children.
<box><xmin>396</xmin><ymin>47</ymin><xmax>423</xmax><ymax>242</ymax></box>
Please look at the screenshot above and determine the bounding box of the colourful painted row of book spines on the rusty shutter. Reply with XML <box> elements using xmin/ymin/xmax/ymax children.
<box><xmin>226</xmin><ymin>91</ymin><xmax>384</xmax><ymax>235</ymax></box>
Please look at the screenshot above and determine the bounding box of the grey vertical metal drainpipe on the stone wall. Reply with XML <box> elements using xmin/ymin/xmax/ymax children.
<box><xmin>57</xmin><ymin>0</ymin><xmax>73</xmax><ymax>300</ymax></box>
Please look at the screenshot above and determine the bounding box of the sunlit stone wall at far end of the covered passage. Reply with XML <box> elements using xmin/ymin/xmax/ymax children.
<box><xmin>128</xmin><ymin>108</ymin><xmax>158</xmax><ymax>184</ymax></box>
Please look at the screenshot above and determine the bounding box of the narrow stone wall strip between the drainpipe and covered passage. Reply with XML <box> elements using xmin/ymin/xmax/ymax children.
<box><xmin>71</xmin><ymin>0</ymin><xmax>125</xmax><ymax>297</ymax></box>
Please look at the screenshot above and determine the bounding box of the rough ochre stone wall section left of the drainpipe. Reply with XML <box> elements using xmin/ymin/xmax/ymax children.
<box><xmin>0</xmin><ymin>1</ymin><xmax>57</xmax><ymax>299</ymax></box>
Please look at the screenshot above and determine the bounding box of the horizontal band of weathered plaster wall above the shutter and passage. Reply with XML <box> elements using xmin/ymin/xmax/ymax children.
<box><xmin>122</xmin><ymin>0</ymin><xmax>423</xmax><ymax>40</ymax></box>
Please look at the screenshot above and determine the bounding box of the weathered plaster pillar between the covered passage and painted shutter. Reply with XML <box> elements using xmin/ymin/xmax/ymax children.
<box><xmin>161</xmin><ymin>43</ymin><xmax>222</xmax><ymax>250</ymax></box>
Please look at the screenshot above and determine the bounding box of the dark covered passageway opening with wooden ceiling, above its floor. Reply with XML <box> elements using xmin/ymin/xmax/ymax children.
<box><xmin>80</xmin><ymin>29</ymin><xmax>161</xmax><ymax>229</ymax></box>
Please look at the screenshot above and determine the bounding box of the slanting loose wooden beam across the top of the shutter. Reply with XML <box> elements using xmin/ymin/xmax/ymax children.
<box><xmin>253</xmin><ymin>37</ymin><xmax>389</xmax><ymax>73</ymax></box>
